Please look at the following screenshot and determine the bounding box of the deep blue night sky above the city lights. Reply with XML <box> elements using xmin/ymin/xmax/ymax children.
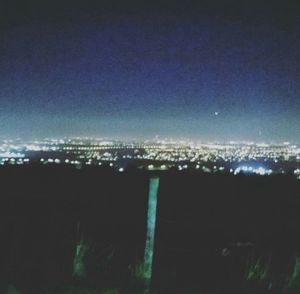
<box><xmin>0</xmin><ymin>0</ymin><xmax>300</xmax><ymax>143</ymax></box>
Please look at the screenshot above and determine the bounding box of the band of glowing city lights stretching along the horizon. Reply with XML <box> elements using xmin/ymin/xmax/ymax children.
<box><xmin>0</xmin><ymin>138</ymin><xmax>300</xmax><ymax>177</ymax></box>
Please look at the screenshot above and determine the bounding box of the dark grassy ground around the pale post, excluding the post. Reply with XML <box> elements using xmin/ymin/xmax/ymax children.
<box><xmin>0</xmin><ymin>166</ymin><xmax>300</xmax><ymax>294</ymax></box>
